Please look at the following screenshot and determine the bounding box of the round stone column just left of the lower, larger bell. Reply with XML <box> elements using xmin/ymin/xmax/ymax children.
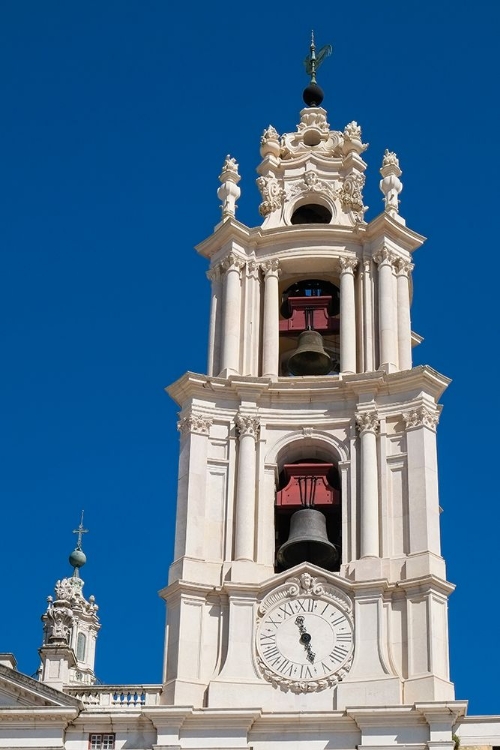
<box><xmin>234</xmin><ymin>413</ymin><xmax>260</xmax><ymax>561</ymax></box>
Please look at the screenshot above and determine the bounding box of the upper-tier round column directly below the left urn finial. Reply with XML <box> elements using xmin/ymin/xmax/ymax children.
<box><xmin>221</xmin><ymin>253</ymin><xmax>245</xmax><ymax>376</ymax></box>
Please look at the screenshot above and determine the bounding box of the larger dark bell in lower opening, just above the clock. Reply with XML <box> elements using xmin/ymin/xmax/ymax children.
<box><xmin>278</xmin><ymin>508</ymin><xmax>339</xmax><ymax>570</ymax></box>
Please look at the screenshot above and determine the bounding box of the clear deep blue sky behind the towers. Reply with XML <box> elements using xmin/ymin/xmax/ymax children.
<box><xmin>0</xmin><ymin>0</ymin><xmax>500</xmax><ymax>714</ymax></box>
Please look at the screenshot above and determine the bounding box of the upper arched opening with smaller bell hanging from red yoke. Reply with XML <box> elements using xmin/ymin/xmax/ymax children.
<box><xmin>279</xmin><ymin>279</ymin><xmax>340</xmax><ymax>377</ymax></box>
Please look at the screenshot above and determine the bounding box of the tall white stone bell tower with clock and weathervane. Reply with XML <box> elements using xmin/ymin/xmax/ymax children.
<box><xmin>162</xmin><ymin>36</ymin><xmax>464</xmax><ymax>748</ymax></box>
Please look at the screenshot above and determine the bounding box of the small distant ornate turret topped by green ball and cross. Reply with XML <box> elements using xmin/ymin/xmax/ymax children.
<box><xmin>39</xmin><ymin>511</ymin><xmax>101</xmax><ymax>690</ymax></box>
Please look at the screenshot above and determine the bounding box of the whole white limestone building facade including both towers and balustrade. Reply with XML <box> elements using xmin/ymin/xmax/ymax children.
<box><xmin>0</xmin><ymin>81</ymin><xmax>500</xmax><ymax>750</ymax></box>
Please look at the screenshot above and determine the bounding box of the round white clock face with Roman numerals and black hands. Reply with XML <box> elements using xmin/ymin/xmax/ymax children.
<box><xmin>257</xmin><ymin>596</ymin><xmax>354</xmax><ymax>683</ymax></box>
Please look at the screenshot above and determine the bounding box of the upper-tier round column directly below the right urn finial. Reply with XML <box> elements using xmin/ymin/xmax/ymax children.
<box><xmin>373</xmin><ymin>247</ymin><xmax>398</xmax><ymax>372</ymax></box>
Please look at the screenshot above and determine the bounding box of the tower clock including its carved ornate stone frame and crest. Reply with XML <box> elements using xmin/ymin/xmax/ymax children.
<box><xmin>255</xmin><ymin>573</ymin><xmax>354</xmax><ymax>693</ymax></box>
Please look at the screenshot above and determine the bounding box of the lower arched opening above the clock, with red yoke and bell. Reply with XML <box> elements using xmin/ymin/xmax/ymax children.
<box><xmin>275</xmin><ymin>457</ymin><xmax>342</xmax><ymax>572</ymax></box>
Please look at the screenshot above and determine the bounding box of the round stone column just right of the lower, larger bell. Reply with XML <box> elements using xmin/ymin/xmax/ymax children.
<box><xmin>356</xmin><ymin>411</ymin><xmax>380</xmax><ymax>557</ymax></box>
